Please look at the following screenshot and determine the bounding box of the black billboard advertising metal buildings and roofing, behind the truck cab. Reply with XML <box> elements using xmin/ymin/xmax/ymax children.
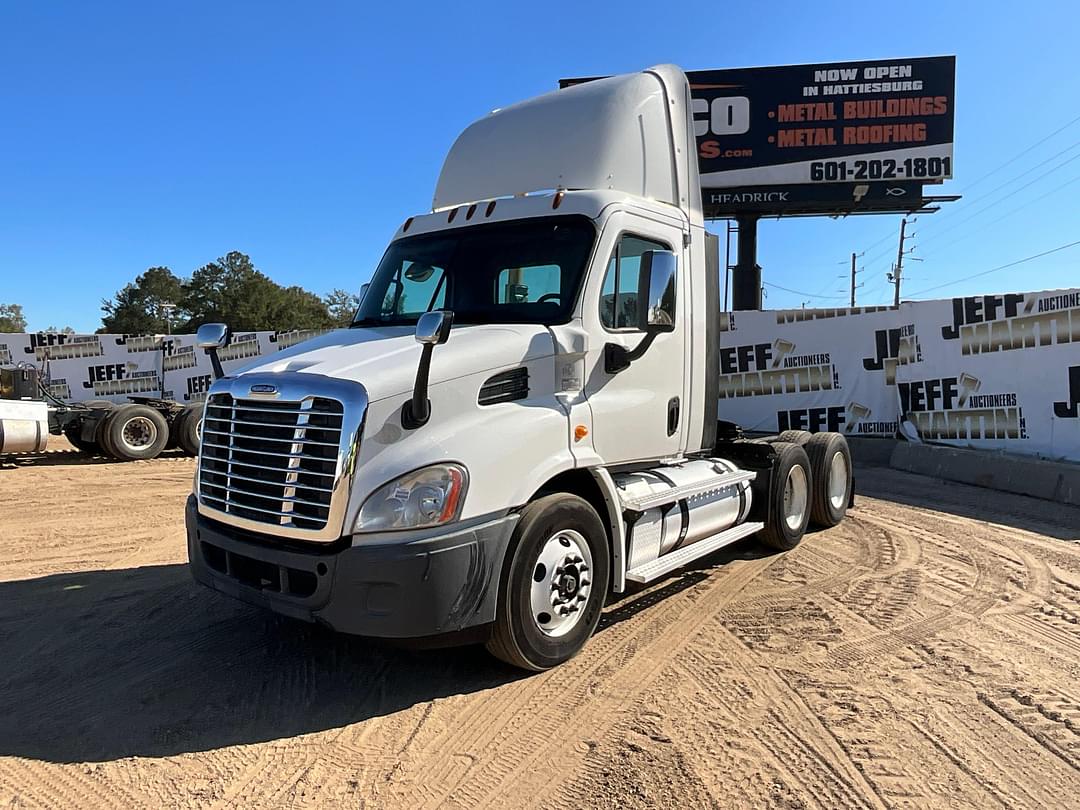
<box><xmin>559</xmin><ymin>56</ymin><xmax>956</xmax><ymax>217</ymax></box>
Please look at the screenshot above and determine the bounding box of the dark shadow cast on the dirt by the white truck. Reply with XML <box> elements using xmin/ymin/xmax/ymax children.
<box><xmin>0</xmin><ymin>543</ymin><xmax>767</xmax><ymax>762</ymax></box>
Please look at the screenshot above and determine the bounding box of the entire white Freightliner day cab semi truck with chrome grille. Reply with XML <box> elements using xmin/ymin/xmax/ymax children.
<box><xmin>187</xmin><ymin>66</ymin><xmax>852</xmax><ymax>670</ymax></box>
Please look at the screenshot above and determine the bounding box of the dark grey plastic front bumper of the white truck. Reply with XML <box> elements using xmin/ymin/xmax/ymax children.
<box><xmin>186</xmin><ymin>496</ymin><xmax>517</xmax><ymax>638</ymax></box>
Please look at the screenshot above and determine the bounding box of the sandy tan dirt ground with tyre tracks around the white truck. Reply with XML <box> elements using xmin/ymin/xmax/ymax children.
<box><xmin>0</xmin><ymin>442</ymin><xmax>1080</xmax><ymax>810</ymax></box>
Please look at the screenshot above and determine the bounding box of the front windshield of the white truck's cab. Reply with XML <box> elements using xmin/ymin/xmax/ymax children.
<box><xmin>352</xmin><ymin>216</ymin><xmax>596</xmax><ymax>326</ymax></box>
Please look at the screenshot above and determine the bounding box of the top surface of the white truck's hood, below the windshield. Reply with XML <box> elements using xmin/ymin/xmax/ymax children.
<box><xmin>236</xmin><ymin>324</ymin><xmax>555</xmax><ymax>402</ymax></box>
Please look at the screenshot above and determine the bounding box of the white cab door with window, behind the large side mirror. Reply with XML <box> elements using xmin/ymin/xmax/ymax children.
<box><xmin>582</xmin><ymin>212</ymin><xmax>688</xmax><ymax>464</ymax></box>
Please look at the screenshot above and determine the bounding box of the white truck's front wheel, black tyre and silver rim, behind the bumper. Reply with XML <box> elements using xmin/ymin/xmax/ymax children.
<box><xmin>487</xmin><ymin>494</ymin><xmax>610</xmax><ymax>672</ymax></box>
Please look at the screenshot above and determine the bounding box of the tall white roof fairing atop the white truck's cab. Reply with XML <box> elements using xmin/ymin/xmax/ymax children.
<box><xmin>432</xmin><ymin>65</ymin><xmax>702</xmax><ymax>225</ymax></box>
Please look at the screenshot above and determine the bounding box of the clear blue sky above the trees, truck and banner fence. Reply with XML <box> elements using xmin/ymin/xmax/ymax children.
<box><xmin>0</xmin><ymin>0</ymin><xmax>1080</xmax><ymax>332</ymax></box>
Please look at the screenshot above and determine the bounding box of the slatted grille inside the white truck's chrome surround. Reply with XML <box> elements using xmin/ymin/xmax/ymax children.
<box><xmin>199</xmin><ymin>393</ymin><xmax>345</xmax><ymax>531</ymax></box>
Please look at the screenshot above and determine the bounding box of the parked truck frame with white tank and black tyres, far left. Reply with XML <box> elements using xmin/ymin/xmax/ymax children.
<box><xmin>0</xmin><ymin>365</ymin><xmax>202</xmax><ymax>461</ymax></box>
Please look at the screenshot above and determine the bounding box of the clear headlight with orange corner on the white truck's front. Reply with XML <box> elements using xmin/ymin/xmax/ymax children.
<box><xmin>353</xmin><ymin>464</ymin><xmax>469</xmax><ymax>532</ymax></box>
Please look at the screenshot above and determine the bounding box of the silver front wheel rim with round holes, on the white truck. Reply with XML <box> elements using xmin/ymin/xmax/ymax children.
<box><xmin>529</xmin><ymin>529</ymin><xmax>593</xmax><ymax>638</ymax></box>
